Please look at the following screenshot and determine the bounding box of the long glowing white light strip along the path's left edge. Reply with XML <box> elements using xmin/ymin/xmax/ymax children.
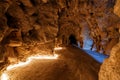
<box><xmin>0</xmin><ymin>54</ymin><xmax>59</xmax><ymax>80</ymax></box>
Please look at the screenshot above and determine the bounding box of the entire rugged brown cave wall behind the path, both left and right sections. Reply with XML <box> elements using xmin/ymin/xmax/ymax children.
<box><xmin>0</xmin><ymin>0</ymin><xmax>120</xmax><ymax>69</ymax></box>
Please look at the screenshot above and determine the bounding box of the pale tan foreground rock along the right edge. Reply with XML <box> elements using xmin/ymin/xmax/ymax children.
<box><xmin>99</xmin><ymin>0</ymin><xmax>120</xmax><ymax>80</ymax></box>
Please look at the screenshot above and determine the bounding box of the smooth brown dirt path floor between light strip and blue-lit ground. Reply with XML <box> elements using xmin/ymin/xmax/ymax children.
<box><xmin>3</xmin><ymin>46</ymin><xmax>100</xmax><ymax>80</ymax></box>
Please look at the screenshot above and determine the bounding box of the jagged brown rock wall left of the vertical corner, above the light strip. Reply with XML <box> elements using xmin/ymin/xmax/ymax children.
<box><xmin>0</xmin><ymin>0</ymin><xmax>58</xmax><ymax>63</ymax></box>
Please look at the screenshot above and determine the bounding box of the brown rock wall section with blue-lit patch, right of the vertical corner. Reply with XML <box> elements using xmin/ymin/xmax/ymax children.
<box><xmin>55</xmin><ymin>0</ymin><xmax>120</xmax><ymax>54</ymax></box>
